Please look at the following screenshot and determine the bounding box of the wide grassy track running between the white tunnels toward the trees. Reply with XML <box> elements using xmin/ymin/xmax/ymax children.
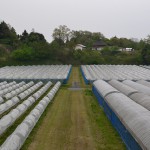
<box><xmin>22</xmin><ymin>67</ymin><xmax>126</xmax><ymax>150</ymax></box>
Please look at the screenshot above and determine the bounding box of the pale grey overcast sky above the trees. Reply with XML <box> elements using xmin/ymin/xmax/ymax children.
<box><xmin>0</xmin><ymin>0</ymin><xmax>150</xmax><ymax>42</ymax></box>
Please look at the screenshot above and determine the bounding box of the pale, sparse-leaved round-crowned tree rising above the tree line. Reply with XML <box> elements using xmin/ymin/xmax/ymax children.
<box><xmin>52</xmin><ymin>25</ymin><xmax>70</xmax><ymax>43</ymax></box>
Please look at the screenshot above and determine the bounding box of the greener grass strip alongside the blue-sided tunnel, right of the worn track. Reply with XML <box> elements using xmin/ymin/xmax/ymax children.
<box><xmin>84</xmin><ymin>90</ymin><xmax>126</xmax><ymax>150</ymax></box>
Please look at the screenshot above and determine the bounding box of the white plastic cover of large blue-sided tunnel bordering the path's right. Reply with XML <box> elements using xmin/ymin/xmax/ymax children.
<box><xmin>93</xmin><ymin>81</ymin><xmax>150</xmax><ymax>150</ymax></box>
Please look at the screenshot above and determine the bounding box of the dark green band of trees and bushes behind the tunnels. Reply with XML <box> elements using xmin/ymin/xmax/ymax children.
<box><xmin>0</xmin><ymin>21</ymin><xmax>150</xmax><ymax>65</ymax></box>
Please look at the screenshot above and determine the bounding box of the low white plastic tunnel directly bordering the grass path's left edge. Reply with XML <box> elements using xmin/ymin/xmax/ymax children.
<box><xmin>0</xmin><ymin>82</ymin><xmax>61</xmax><ymax>150</ymax></box>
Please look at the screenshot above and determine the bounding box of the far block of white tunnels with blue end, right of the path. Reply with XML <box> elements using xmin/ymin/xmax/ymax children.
<box><xmin>81</xmin><ymin>65</ymin><xmax>150</xmax><ymax>84</ymax></box>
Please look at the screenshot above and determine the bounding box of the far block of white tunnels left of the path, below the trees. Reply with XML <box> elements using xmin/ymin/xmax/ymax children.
<box><xmin>0</xmin><ymin>65</ymin><xmax>72</xmax><ymax>82</ymax></box>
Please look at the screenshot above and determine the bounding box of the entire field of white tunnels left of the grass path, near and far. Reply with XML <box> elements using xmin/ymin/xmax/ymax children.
<box><xmin>0</xmin><ymin>65</ymin><xmax>68</xmax><ymax>150</ymax></box>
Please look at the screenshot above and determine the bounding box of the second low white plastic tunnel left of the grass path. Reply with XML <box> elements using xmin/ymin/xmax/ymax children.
<box><xmin>0</xmin><ymin>82</ymin><xmax>52</xmax><ymax>135</ymax></box>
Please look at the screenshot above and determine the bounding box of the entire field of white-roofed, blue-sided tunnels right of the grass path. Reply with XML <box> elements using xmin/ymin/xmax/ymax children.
<box><xmin>81</xmin><ymin>65</ymin><xmax>150</xmax><ymax>150</ymax></box>
